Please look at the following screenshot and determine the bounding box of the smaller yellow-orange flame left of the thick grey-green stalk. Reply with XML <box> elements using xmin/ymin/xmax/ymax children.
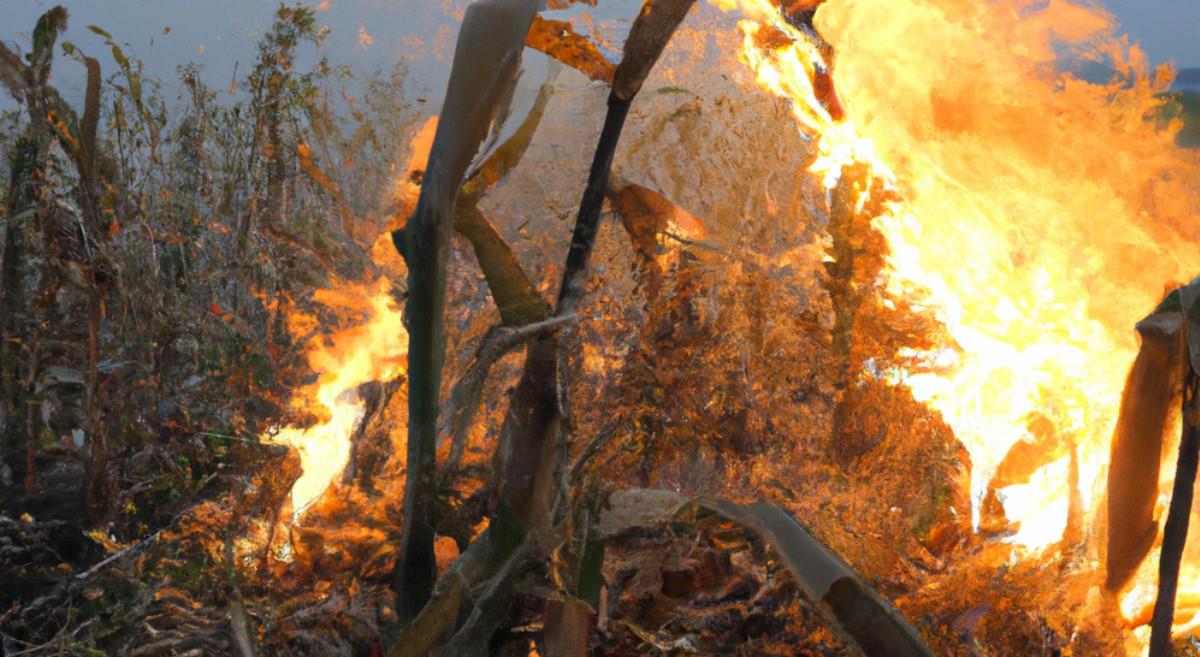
<box><xmin>264</xmin><ymin>278</ymin><xmax>408</xmax><ymax>513</ymax></box>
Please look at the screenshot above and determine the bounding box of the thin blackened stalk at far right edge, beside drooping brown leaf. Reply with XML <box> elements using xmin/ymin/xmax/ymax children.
<box><xmin>1150</xmin><ymin>370</ymin><xmax>1200</xmax><ymax>657</ymax></box>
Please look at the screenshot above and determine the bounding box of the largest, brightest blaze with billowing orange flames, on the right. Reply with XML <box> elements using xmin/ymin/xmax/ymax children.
<box><xmin>712</xmin><ymin>0</ymin><xmax>1200</xmax><ymax>642</ymax></box>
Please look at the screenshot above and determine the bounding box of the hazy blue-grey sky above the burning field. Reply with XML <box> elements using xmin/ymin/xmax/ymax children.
<box><xmin>0</xmin><ymin>0</ymin><xmax>1200</xmax><ymax>107</ymax></box>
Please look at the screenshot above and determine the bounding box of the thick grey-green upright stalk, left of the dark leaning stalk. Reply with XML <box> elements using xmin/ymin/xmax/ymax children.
<box><xmin>392</xmin><ymin>0</ymin><xmax>536</xmax><ymax>625</ymax></box>
